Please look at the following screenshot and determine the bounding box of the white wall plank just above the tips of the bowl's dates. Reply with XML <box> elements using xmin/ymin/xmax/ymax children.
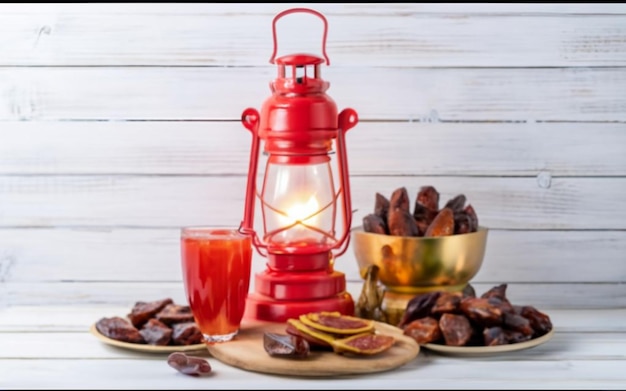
<box><xmin>0</xmin><ymin>121</ymin><xmax>626</xmax><ymax>176</ymax></box>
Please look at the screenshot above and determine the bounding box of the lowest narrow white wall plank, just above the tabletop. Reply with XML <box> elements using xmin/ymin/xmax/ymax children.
<box><xmin>0</xmin><ymin>279</ymin><xmax>626</xmax><ymax>310</ymax></box>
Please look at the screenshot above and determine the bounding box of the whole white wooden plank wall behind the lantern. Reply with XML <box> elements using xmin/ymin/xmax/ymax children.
<box><xmin>0</xmin><ymin>3</ymin><xmax>626</xmax><ymax>308</ymax></box>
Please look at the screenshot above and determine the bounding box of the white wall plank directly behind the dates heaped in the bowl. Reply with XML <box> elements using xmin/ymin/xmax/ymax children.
<box><xmin>0</xmin><ymin>175</ymin><xmax>626</xmax><ymax>230</ymax></box>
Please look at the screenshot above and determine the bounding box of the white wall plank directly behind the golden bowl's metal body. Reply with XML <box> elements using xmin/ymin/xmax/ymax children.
<box><xmin>0</xmin><ymin>228</ymin><xmax>626</xmax><ymax>283</ymax></box>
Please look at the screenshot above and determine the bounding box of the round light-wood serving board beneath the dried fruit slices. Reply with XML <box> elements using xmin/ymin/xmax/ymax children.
<box><xmin>207</xmin><ymin>320</ymin><xmax>420</xmax><ymax>377</ymax></box>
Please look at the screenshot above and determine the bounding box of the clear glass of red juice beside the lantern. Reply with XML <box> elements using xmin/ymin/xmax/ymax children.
<box><xmin>181</xmin><ymin>227</ymin><xmax>252</xmax><ymax>343</ymax></box>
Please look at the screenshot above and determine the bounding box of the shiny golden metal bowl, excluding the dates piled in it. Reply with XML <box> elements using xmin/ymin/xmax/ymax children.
<box><xmin>351</xmin><ymin>227</ymin><xmax>488</xmax><ymax>294</ymax></box>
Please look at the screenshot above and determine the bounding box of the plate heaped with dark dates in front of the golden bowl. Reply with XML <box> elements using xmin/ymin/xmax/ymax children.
<box><xmin>399</xmin><ymin>284</ymin><xmax>554</xmax><ymax>355</ymax></box>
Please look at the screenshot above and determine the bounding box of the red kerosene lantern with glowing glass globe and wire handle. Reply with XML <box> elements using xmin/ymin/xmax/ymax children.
<box><xmin>240</xmin><ymin>8</ymin><xmax>358</xmax><ymax>322</ymax></box>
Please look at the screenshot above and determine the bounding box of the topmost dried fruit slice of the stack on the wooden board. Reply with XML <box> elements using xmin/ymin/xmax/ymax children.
<box><xmin>299</xmin><ymin>311</ymin><xmax>374</xmax><ymax>335</ymax></box>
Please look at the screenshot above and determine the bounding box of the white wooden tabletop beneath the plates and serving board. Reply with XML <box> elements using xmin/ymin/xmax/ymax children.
<box><xmin>0</xmin><ymin>305</ymin><xmax>626</xmax><ymax>390</ymax></box>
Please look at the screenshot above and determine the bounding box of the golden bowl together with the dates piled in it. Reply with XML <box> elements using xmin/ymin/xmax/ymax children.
<box><xmin>351</xmin><ymin>186</ymin><xmax>488</xmax><ymax>298</ymax></box>
